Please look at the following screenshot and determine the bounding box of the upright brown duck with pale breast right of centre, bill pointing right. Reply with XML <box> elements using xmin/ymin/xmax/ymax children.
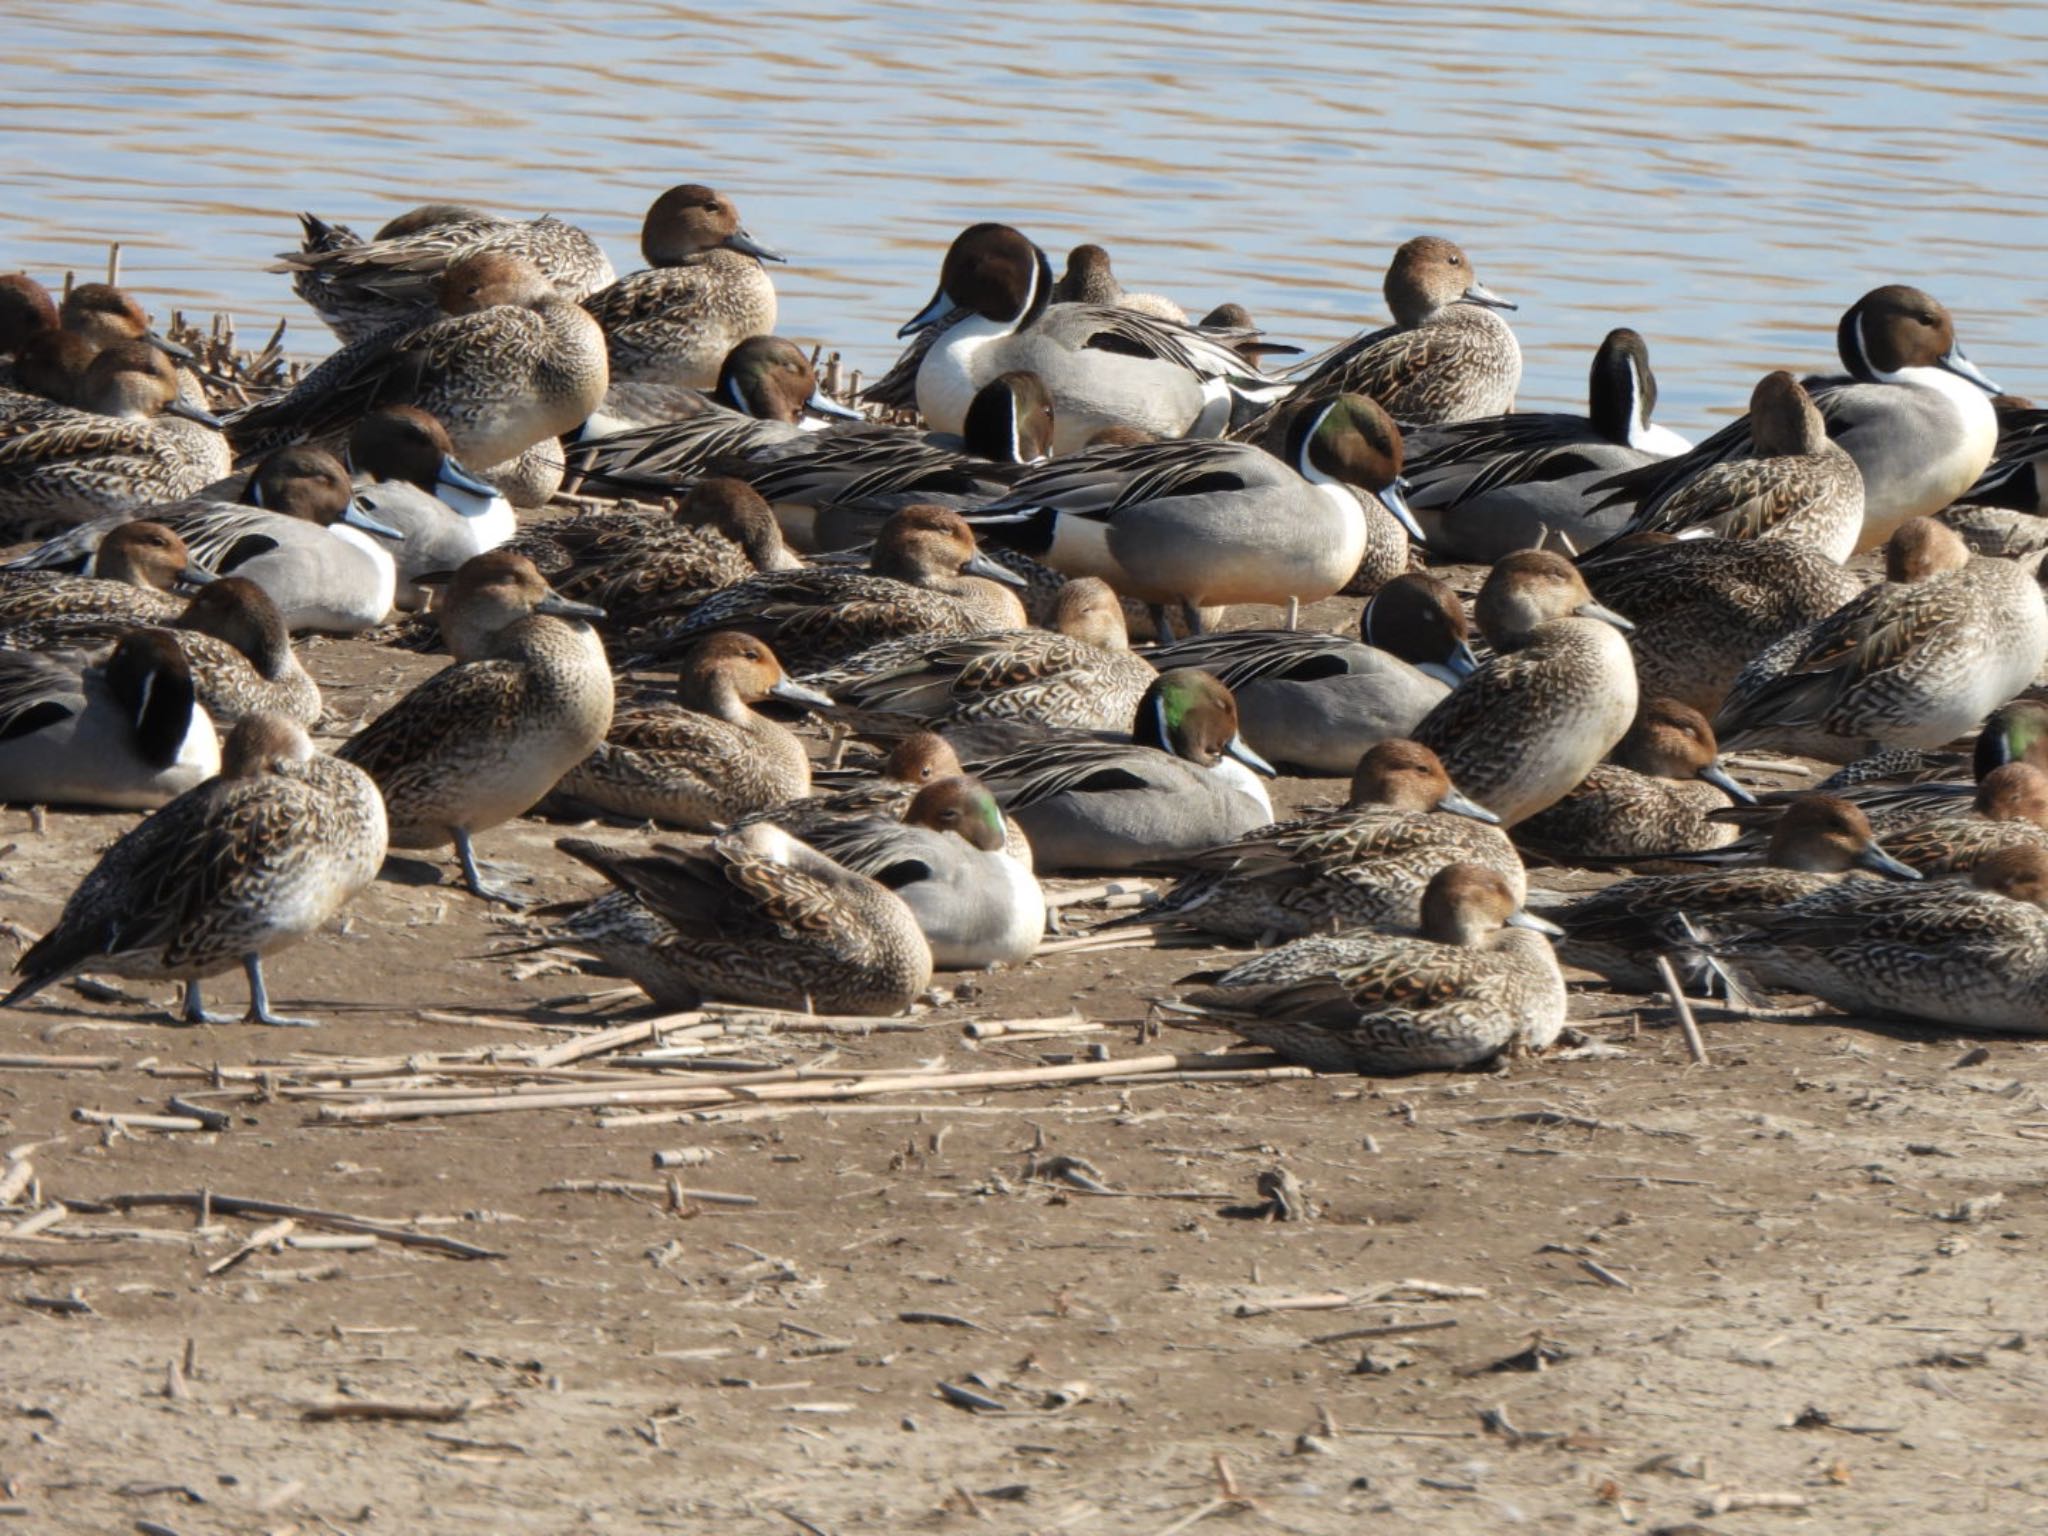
<box><xmin>1415</xmin><ymin>549</ymin><xmax>1636</xmax><ymax>827</ymax></box>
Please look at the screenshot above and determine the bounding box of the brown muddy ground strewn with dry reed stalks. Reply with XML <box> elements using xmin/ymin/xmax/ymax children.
<box><xmin>0</xmin><ymin>608</ymin><xmax>2048</xmax><ymax>1536</ymax></box>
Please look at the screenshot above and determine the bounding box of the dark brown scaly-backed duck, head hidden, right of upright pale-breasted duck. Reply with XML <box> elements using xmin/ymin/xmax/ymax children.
<box><xmin>1579</xmin><ymin>535</ymin><xmax>1864</xmax><ymax>715</ymax></box>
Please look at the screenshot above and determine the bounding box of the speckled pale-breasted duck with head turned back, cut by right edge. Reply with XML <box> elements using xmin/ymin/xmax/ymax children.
<box><xmin>1714</xmin><ymin>518</ymin><xmax>2048</xmax><ymax>762</ymax></box>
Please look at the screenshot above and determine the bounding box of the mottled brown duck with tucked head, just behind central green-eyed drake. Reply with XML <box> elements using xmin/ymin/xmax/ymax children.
<box><xmin>807</xmin><ymin>575</ymin><xmax>1157</xmax><ymax>731</ymax></box>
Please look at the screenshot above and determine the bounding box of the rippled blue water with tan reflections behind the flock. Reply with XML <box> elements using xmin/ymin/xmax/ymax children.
<box><xmin>0</xmin><ymin>0</ymin><xmax>2048</xmax><ymax>430</ymax></box>
